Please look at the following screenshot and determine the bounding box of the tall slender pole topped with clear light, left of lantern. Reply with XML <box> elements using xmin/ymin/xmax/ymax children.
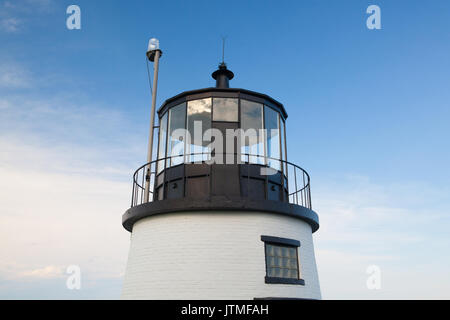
<box><xmin>144</xmin><ymin>38</ymin><xmax>162</xmax><ymax>202</ymax></box>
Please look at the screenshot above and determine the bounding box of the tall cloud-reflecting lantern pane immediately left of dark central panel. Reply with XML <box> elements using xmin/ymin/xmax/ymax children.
<box><xmin>186</xmin><ymin>98</ymin><xmax>211</xmax><ymax>162</ymax></box>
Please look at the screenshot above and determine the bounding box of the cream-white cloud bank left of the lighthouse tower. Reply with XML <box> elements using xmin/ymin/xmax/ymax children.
<box><xmin>0</xmin><ymin>142</ymin><xmax>130</xmax><ymax>290</ymax></box>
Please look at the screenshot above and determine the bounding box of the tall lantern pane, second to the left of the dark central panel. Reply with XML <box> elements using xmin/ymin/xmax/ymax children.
<box><xmin>167</xmin><ymin>103</ymin><xmax>186</xmax><ymax>167</ymax></box>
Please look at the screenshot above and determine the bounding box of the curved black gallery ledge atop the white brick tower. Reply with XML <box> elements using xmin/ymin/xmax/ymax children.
<box><xmin>122</xmin><ymin>196</ymin><xmax>319</xmax><ymax>232</ymax></box>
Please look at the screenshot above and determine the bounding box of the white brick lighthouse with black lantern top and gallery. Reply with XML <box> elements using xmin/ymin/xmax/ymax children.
<box><xmin>122</xmin><ymin>57</ymin><xmax>321</xmax><ymax>300</ymax></box>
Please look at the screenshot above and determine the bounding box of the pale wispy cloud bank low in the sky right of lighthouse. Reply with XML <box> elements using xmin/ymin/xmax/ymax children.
<box><xmin>313</xmin><ymin>175</ymin><xmax>450</xmax><ymax>299</ymax></box>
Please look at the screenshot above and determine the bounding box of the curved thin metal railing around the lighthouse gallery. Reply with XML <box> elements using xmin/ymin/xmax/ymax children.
<box><xmin>131</xmin><ymin>153</ymin><xmax>312</xmax><ymax>209</ymax></box>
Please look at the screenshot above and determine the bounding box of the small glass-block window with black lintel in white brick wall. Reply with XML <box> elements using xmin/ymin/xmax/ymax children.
<box><xmin>261</xmin><ymin>236</ymin><xmax>305</xmax><ymax>285</ymax></box>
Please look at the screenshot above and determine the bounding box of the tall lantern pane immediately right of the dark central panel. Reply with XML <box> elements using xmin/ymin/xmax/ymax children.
<box><xmin>241</xmin><ymin>100</ymin><xmax>264</xmax><ymax>164</ymax></box>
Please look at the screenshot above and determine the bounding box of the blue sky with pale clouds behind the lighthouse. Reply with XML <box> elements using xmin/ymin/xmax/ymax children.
<box><xmin>0</xmin><ymin>0</ymin><xmax>450</xmax><ymax>299</ymax></box>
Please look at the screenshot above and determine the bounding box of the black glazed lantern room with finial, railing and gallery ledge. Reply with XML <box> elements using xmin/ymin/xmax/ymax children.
<box><xmin>124</xmin><ymin>63</ymin><xmax>319</xmax><ymax>235</ymax></box>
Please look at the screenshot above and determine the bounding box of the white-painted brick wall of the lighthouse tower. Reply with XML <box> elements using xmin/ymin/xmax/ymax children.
<box><xmin>122</xmin><ymin>211</ymin><xmax>321</xmax><ymax>299</ymax></box>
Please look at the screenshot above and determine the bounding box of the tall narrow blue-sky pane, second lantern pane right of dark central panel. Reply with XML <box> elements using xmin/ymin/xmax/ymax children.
<box><xmin>264</xmin><ymin>106</ymin><xmax>281</xmax><ymax>170</ymax></box>
